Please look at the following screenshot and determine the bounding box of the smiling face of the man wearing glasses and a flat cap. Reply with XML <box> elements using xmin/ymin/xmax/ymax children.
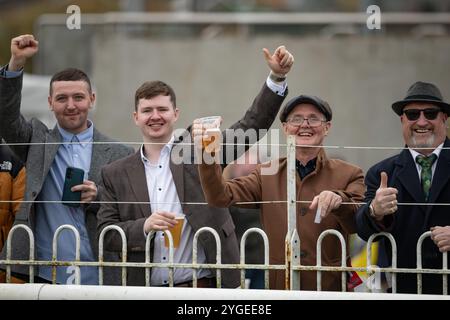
<box><xmin>283</xmin><ymin>103</ymin><xmax>331</xmax><ymax>151</ymax></box>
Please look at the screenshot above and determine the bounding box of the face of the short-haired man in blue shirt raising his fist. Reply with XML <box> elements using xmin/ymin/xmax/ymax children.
<box><xmin>48</xmin><ymin>80</ymin><xmax>95</xmax><ymax>134</ymax></box>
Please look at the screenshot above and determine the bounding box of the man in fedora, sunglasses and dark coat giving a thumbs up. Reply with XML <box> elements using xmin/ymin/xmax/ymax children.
<box><xmin>356</xmin><ymin>82</ymin><xmax>450</xmax><ymax>294</ymax></box>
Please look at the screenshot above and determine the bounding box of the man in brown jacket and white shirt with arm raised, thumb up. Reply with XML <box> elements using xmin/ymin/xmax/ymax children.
<box><xmin>98</xmin><ymin>46</ymin><xmax>294</xmax><ymax>288</ymax></box>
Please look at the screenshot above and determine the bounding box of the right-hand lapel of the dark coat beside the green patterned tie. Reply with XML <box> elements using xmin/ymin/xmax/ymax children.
<box><xmin>427</xmin><ymin>139</ymin><xmax>450</xmax><ymax>216</ymax></box>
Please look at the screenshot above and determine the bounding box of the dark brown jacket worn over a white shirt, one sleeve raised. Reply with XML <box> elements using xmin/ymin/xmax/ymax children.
<box><xmin>97</xmin><ymin>85</ymin><xmax>284</xmax><ymax>287</ymax></box>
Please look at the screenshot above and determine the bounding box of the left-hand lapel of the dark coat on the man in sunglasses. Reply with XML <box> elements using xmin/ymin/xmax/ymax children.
<box><xmin>394</xmin><ymin>149</ymin><xmax>425</xmax><ymax>211</ymax></box>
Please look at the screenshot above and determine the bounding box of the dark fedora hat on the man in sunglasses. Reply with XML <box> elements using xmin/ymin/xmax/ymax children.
<box><xmin>392</xmin><ymin>81</ymin><xmax>450</xmax><ymax>116</ymax></box>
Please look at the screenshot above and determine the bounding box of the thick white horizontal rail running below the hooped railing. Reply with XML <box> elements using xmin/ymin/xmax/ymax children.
<box><xmin>0</xmin><ymin>283</ymin><xmax>450</xmax><ymax>300</ymax></box>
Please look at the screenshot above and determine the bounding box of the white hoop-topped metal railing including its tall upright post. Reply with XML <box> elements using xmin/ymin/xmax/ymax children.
<box><xmin>0</xmin><ymin>136</ymin><xmax>450</xmax><ymax>296</ymax></box>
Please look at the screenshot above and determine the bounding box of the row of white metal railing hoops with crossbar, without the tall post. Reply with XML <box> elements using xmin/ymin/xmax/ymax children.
<box><xmin>0</xmin><ymin>225</ymin><xmax>450</xmax><ymax>296</ymax></box>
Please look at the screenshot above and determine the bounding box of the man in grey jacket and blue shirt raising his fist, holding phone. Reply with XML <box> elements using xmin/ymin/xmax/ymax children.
<box><xmin>0</xmin><ymin>35</ymin><xmax>134</xmax><ymax>284</ymax></box>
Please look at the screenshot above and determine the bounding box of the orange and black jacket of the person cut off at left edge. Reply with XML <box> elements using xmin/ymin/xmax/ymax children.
<box><xmin>0</xmin><ymin>144</ymin><xmax>25</xmax><ymax>250</ymax></box>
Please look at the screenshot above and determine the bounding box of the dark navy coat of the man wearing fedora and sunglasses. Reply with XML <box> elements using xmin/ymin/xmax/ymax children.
<box><xmin>356</xmin><ymin>139</ymin><xmax>450</xmax><ymax>294</ymax></box>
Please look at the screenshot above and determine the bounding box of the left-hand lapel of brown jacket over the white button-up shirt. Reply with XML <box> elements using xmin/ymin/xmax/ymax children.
<box><xmin>125</xmin><ymin>150</ymin><xmax>152</xmax><ymax>218</ymax></box>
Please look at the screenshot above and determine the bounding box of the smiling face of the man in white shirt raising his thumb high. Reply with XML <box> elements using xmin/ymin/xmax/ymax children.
<box><xmin>133</xmin><ymin>95</ymin><xmax>179</xmax><ymax>143</ymax></box>
